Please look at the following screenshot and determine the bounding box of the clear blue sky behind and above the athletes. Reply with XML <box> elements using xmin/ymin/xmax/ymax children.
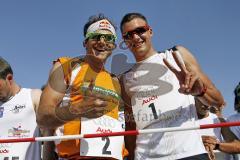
<box><xmin>0</xmin><ymin>0</ymin><xmax>240</xmax><ymax>116</ymax></box>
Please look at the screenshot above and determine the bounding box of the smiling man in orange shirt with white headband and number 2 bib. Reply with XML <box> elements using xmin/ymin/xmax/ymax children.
<box><xmin>37</xmin><ymin>14</ymin><xmax>127</xmax><ymax>159</ymax></box>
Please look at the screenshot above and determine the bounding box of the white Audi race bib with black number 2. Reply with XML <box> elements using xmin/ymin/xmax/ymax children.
<box><xmin>80</xmin><ymin>115</ymin><xmax>124</xmax><ymax>160</ymax></box>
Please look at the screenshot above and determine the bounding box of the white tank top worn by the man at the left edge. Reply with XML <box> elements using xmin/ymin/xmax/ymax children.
<box><xmin>0</xmin><ymin>88</ymin><xmax>40</xmax><ymax>160</ymax></box>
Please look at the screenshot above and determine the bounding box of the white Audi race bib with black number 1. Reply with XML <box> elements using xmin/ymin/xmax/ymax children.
<box><xmin>132</xmin><ymin>88</ymin><xmax>189</xmax><ymax>129</ymax></box>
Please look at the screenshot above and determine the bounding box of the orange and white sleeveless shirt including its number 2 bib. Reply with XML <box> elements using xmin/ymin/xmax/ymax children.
<box><xmin>53</xmin><ymin>58</ymin><xmax>125</xmax><ymax>159</ymax></box>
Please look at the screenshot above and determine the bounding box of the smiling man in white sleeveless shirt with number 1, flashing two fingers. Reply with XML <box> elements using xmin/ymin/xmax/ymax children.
<box><xmin>121</xmin><ymin>13</ymin><xmax>223</xmax><ymax>160</ymax></box>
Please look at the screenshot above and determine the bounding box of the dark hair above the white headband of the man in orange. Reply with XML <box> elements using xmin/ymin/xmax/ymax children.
<box><xmin>83</xmin><ymin>13</ymin><xmax>117</xmax><ymax>37</ymax></box>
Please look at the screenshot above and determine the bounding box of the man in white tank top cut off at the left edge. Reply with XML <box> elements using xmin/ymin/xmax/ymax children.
<box><xmin>0</xmin><ymin>57</ymin><xmax>41</xmax><ymax>160</ymax></box>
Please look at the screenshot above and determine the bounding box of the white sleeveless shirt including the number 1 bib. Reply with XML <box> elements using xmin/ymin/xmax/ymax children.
<box><xmin>123</xmin><ymin>50</ymin><xmax>206</xmax><ymax>160</ymax></box>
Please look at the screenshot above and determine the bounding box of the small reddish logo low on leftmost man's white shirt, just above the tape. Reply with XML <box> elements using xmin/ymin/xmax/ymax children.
<box><xmin>8</xmin><ymin>126</ymin><xmax>30</xmax><ymax>137</ymax></box>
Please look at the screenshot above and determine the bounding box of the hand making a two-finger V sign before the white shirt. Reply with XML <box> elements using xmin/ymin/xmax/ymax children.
<box><xmin>163</xmin><ymin>52</ymin><xmax>204</xmax><ymax>96</ymax></box>
